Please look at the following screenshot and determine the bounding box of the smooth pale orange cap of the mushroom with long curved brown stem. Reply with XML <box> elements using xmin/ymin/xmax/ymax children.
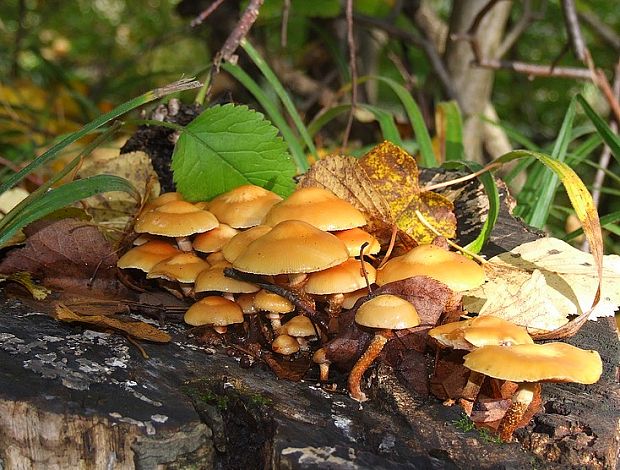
<box><xmin>355</xmin><ymin>294</ymin><xmax>420</xmax><ymax>330</ymax></box>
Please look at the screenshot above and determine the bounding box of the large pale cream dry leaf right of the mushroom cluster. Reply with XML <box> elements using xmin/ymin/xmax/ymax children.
<box><xmin>463</xmin><ymin>238</ymin><xmax>620</xmax><ymax>331</ymax></box>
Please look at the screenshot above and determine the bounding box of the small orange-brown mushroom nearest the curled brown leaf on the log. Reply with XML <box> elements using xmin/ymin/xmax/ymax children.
<box><xmin>183</xmin><ymin>296</ymin><xmax>243</xmax><ymax>334</ymax></box>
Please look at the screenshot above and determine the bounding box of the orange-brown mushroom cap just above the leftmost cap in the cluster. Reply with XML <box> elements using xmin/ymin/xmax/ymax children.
<box><xmin>134</xmin><ymin>201</ymin><xmax>219</xmax><ymax>237</ymax></box>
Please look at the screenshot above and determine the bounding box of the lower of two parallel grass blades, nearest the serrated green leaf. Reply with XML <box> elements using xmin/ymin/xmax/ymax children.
<box><xmin>222</xmin><ymin>62</ymin><xmax>308</xmax><ymax>173</ymax></box>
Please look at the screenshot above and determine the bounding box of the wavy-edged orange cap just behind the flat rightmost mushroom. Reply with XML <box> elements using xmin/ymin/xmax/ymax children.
<box><xmin>428</xmin><ymin>315</ymin><xmax>534</xmax><ymax>351</ymax></box>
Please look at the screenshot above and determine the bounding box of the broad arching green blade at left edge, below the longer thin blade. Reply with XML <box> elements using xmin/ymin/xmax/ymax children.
<box><xmin>0</xmin><ymin>175</ymin><xmax>140</xmax><ymax>246</ymax></box>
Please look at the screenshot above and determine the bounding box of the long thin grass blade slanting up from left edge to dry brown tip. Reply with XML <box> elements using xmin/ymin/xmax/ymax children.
<box><xmin>0</xmin><ymin>79</ymin><xmax>200</xmax><ymax>194</ymax></box>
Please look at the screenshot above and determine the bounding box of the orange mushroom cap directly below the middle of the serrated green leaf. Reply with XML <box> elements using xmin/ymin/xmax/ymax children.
<box><xmin>209</xmin><ymin>184</ymin><xmax>282</xmax><ymax>228</ymax></box>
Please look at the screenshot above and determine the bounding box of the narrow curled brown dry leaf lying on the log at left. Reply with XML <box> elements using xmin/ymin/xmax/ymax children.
<box><xmin>56</xmin><ymin>303</ymin><xmax>171</xmax><ymax>343</ymax></box>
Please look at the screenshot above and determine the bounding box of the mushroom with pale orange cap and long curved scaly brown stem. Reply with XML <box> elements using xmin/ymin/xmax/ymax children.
<box><xmin>348</xmin><ymin>294</ymin><xmax>420</xmax><ymax>401</ymax></box>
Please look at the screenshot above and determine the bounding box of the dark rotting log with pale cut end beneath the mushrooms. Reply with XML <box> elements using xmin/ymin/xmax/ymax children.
<box><xmin>0</xmin><ymin>167</ymin><xmax>620</xmax><ymax>469</ymax></box>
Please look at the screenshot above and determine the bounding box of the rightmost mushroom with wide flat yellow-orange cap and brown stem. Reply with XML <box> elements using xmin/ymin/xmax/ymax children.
<box><xmin>464</xmin><ymin>342</ymin><xmax>603</xmax><ymax>441</ymax></box>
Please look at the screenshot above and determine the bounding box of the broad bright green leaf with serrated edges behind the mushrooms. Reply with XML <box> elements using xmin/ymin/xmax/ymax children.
<box><xmin>172</xmin><ymin>104</ymin><xmax>295</xmax><ymax>201</ymax></box>
